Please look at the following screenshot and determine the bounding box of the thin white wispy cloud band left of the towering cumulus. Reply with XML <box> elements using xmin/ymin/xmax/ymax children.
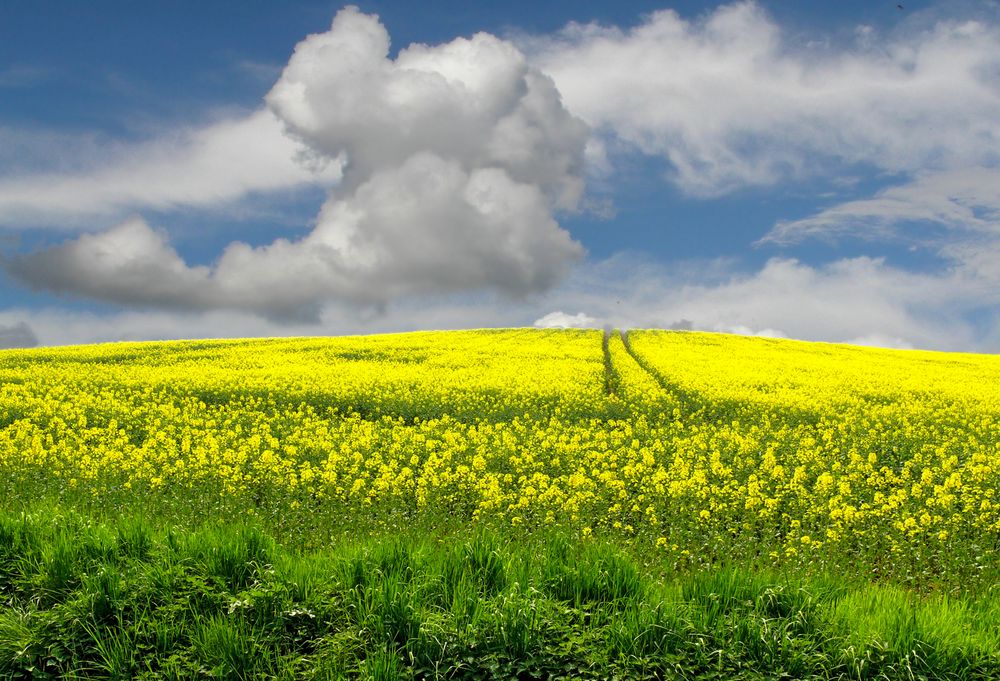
<box><xmin>0</xmin><ymin>110</ymin><xmax>340</xmax><ymax>228</ymax></box>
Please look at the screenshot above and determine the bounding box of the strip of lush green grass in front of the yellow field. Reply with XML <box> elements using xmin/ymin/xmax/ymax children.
<box><xmin>0</xmin><ymin>505</ymin><xmax>1000</xmax><ymax>679</ymax></box>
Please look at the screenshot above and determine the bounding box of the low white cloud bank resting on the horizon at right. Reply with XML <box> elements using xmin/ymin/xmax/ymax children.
<box><xmin>532</xmin><ymin>254</ymin><xmax>1000</xmax><ymax>352</ymax></box>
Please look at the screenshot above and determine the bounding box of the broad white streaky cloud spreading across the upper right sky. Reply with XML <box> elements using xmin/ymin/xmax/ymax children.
<box><xmin>527</xmin><ymin>2</ymin><xmax>1000</xmax><ymax>197</ymax></box>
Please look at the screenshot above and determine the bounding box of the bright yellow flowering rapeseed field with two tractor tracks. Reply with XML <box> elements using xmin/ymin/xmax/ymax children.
<box><xmin>0</xmin><ymin>329</ymin><xmax>1000</xmax><ymax>579</ymax></box>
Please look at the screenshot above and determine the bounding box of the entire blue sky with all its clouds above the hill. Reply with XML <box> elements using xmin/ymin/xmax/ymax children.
<box><xmin>0</xmin><ymin>0</ymin><xmax>1000</xmax><ymax>352</ymax></box>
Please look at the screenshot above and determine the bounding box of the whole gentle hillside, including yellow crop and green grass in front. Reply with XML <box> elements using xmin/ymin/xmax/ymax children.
<box><xmin>0</xmin><ymin>329</ymin><xmax>1000</xmax><ymax>679</ymax></box>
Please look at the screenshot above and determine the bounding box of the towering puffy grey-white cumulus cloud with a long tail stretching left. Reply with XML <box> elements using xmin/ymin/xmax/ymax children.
<box><xmin>9</xmin><ymin>7</ymin><xmax>588</xmax><ymax>319</ymax></box>
